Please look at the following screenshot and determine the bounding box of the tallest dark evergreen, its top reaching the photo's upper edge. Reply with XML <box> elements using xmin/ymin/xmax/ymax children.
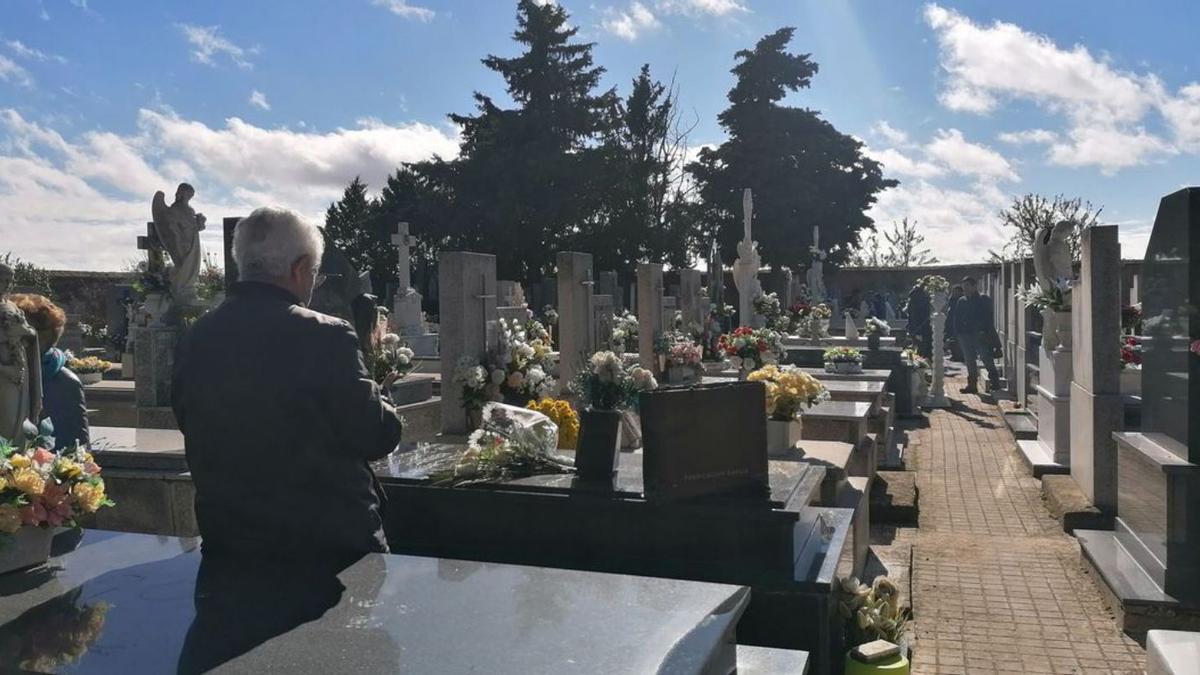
<box><xmin>415</xmin><ymin>0</ymin><xmax>616</xmax><ymax>280</ymax></box>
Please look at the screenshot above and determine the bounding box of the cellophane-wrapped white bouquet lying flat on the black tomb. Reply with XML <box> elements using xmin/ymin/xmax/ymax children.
<box><xmin>430</xmin><ymin>402</ymin><xmax>572</xmax><ymax>485</ymax></box>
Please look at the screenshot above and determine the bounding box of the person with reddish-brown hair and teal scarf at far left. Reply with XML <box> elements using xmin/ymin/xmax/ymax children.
<box><xmin>8</xmin><ymin>293</ymin><xmax>89</xmax><ymax>450</ymax></box>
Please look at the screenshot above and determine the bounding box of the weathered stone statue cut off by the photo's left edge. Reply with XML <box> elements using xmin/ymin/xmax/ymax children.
<box><xmin>0</xmin><ymin>263</ymin><xmax>42</xmax><ymax>443</ymax></box>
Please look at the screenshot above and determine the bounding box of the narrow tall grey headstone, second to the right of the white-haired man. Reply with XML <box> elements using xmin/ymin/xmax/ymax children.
<box><xmin>556</xmin><ymin>251</ymin><xmax>595</xmax><ymax>392</ymax></box>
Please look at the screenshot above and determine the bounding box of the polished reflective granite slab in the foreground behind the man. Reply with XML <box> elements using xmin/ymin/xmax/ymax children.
<box><xmin>0</xmin><ymin>531</ymin><xmax>749</xmax><ymax>673</ymax></box>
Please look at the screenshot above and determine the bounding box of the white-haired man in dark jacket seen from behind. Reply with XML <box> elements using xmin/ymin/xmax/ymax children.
<box><xmin>173</xmin><ymin>208</ymin><xmax>401</xmax><ymax>560</ymax></box>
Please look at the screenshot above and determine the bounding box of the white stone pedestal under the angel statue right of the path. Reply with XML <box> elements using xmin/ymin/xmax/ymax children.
<box><xmin>1016</xmin><ymin>348</ymin><xmax>1073</xmax><ymax>478</ymax></box>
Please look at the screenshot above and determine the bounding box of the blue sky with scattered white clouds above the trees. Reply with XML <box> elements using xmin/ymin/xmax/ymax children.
<box><xmin>0</xmin><ymin>0</ymin><xmax>1200</xmax><ymax>269</ymax></box>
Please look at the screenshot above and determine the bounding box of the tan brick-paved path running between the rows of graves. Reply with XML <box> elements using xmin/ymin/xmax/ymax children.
<box><xmin>892</xmin><ymin>378</ymin><xmax>1145</xmax><ymax>674</ymax></box>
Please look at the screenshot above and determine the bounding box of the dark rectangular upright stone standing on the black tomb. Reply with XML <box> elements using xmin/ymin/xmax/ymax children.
<box><xmin>640</xmin><ymin>382</ymin><xmax>769</xmax><ymax>503</ymax></box>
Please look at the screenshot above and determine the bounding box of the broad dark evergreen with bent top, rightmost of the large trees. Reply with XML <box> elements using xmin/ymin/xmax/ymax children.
<box><xmin>688</xmin><ymin>28</ymin><xmax>898</xmax><ymax>267</ymax></box>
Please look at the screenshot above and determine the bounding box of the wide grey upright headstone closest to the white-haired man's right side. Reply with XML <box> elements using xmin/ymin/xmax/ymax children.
<box><xmin>438</xmin><ymin>251</ymin><xmax>496</xmax><ymax>434</ymax></box>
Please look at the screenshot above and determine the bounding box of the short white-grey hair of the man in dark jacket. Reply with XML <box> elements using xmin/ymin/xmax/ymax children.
<box><xmin>233</xmin><ymin>207</ymin><xmax>325</xmax><ymax>281</ymax></box>
